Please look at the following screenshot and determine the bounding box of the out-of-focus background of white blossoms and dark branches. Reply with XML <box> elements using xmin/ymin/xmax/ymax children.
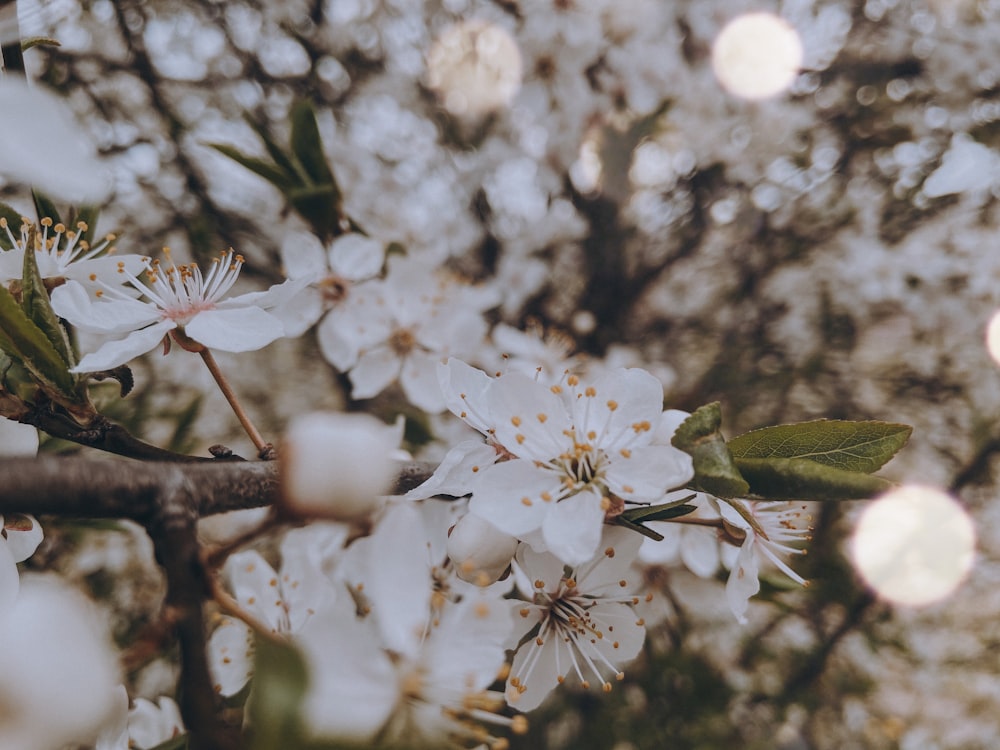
<box><xmin>9</xmin><ymin>0</ymin><xmax>1000</xmax><ymax>750</ymax></box>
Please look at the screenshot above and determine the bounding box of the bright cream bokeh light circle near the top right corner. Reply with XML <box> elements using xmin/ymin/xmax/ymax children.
<box><xmin>712</xmin><ymin>13</ymin><xmax>802</xmax><ymax>99</ymax></box>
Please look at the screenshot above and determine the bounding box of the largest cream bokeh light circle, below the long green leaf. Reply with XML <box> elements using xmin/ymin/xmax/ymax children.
<box><xmin>850</xmin><ymin>485</ymin><xmax>976</xmax><ymax>606</ymax></box>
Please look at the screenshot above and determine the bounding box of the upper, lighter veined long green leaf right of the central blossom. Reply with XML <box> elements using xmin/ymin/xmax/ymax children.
<box><xmin>728</xmin><ymin>419</ymin><xmax>913</xmax><ymax>474</ymax></box>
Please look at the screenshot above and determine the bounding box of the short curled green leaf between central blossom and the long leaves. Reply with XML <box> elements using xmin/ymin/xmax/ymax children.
<box><xmin>670</xmin><ymin>401</ymin><xmax>750</xmax><ymax>497</ymax></box>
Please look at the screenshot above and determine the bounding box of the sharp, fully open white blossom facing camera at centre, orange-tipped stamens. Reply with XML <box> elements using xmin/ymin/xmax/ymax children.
<box><xmin>431</xmin><ymin>362</ymin><xmax>692</xmax><ymax>565</ymax></box>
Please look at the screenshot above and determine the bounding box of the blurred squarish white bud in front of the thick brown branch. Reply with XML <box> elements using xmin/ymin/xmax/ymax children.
<box><xmin>279</xmin><ymin>412</ymin><xmax>399</xmax><ymax>521</ymax></box>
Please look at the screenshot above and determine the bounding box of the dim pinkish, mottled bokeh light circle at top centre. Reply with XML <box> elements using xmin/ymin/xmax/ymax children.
<box><xmin>427</xmin><ymin>20</ymin><xmax>523</xmax><ymax>117</ymax></box>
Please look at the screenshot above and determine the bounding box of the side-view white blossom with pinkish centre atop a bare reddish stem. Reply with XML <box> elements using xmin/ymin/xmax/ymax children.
<box><xmin>52</xmin><ymin>250</ymin><xmax>304</xmax><ymax>372</ymax></box>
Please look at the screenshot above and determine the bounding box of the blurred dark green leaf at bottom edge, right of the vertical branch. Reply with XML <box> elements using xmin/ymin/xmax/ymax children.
<box><xmin>247</xmin><ymin>636</ymin><xmax>308</xmax><ymax>750</ymax></box>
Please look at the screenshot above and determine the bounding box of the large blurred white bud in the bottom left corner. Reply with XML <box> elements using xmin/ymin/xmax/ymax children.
<box><xmin>0</xmin><ymin>577</ymin><xmax>121</xmax><ymax>750</ymax></box>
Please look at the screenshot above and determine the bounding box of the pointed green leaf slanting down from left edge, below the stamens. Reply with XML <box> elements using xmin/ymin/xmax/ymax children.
<box><xmin>0</xmin><ymin>286</ymin><xmax>78</xmax><ymax>402</ymax></box>
